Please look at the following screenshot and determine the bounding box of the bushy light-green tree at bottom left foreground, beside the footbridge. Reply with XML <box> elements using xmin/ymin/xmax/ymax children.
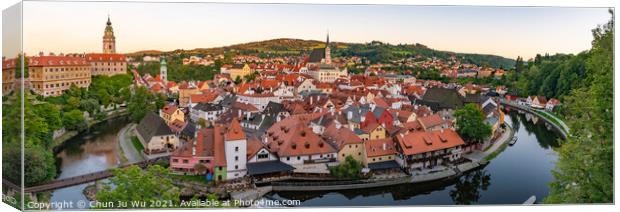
<box><xmin>96</xmin><ymin>165</ymin><xmax>181</xmax><ymax>208</ymax></box>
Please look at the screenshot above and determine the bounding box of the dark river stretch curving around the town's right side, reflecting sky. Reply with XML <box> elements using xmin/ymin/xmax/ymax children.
<box><xmin>267</xmin><ymin>110</ymin><xmax>558</xmax><ymax>206</ymax></box>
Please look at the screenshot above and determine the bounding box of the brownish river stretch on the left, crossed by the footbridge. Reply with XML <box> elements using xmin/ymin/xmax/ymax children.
<box><xmin>51</xmin><ymin>117</ymin><xmax>129</xmax><ymax>210</ymax></box>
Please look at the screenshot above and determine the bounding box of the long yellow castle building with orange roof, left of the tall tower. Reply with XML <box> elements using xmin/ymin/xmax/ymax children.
<box><xmin>27</xmin><ymin>54</ymin><xmax>91</xmax><ymax>96</ymax></box>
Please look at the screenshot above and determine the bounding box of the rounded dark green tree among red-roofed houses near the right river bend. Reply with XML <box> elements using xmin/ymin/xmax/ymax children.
<box><xmin>454</xmin><ymin>104</ymin><xmax>492</xmax><ymax>144</ymax></box>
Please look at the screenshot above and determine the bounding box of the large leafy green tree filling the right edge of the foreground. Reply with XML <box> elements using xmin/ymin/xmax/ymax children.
<box><xmin>545</xmin><ymin>10</ymin><xmax>614</xmax><ymax>203</ymax></box>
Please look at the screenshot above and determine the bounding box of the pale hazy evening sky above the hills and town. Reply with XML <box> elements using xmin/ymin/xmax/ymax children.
<box><xmin>9</xmin><ymin>2</ymin><xmax>610</xmax><ymax>58</ymax></box>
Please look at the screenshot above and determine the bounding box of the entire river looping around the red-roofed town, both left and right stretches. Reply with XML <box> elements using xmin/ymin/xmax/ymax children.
<box><xmin>51</xmin><ymin>108</ymin><xmax>558</xmax><ymax>206</ymax></box>
